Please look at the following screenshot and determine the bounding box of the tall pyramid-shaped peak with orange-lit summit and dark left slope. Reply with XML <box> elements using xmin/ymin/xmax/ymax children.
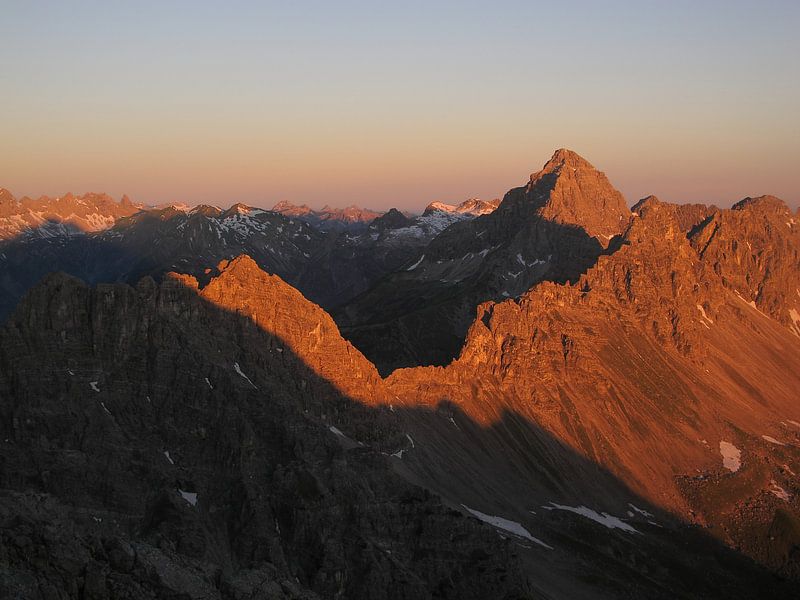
<box><xmin>334</xmin><ymin>150</ymin><xmax>630</xmax><ymax>373</ymax></box>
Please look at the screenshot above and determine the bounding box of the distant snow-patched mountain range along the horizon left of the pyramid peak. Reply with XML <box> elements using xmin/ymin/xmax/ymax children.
<box><xmin>0</xmin><ymin>190</ymin><xmax>504</xmax><ymax>317</ymax></box>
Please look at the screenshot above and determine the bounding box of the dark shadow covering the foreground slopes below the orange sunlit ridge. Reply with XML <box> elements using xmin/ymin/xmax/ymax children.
<box><xmin>0</xmin><ymin>268</ymin><xmax>791</xmax><ymax>599</ymax></box>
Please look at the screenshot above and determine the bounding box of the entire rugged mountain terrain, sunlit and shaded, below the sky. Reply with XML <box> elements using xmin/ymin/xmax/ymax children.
<box><xmin>0</xmin><ymin>149</ymin><xmax>800</xmax><ymax>600</ymax></box>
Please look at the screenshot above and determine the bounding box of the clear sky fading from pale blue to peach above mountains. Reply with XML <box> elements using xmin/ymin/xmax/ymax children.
<box><xmin>0</xmin><ymin>0</ymin><xmax>800</xmax><ymax>210</ymax></box>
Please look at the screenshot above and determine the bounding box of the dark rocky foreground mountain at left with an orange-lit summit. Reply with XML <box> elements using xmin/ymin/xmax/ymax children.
<box><xmin>0</xmin><ymin>258</ymin><xmax>529</xmax><ymax>599</ymax></box>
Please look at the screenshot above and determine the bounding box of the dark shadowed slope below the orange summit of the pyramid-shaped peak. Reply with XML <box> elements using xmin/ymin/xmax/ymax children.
<box><xmin>333</xmin><ymin>218</ymin><xmax>614</xmax><ymax>376</ymax></box>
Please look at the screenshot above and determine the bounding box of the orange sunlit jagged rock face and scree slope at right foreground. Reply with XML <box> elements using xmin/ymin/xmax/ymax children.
<box><xmin>388</xmin><ymin>193</ymin><xmax>800</xmax><ymax>578</ymax></box>
